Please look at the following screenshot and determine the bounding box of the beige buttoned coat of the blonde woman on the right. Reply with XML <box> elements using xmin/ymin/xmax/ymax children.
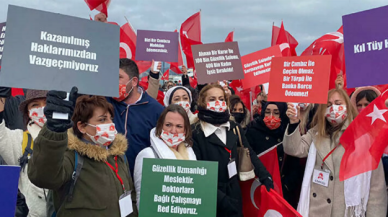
<box><xmin>283</xmin><ymin>124</ymin><xmax>387</xmax><ymax>217</ymax></box>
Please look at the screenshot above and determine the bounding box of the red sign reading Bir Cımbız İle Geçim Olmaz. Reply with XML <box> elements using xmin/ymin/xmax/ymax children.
<box><xmin>268</xmin><ymin>55</ymin><xmax>331</xmax><ymax>104</ymax></box>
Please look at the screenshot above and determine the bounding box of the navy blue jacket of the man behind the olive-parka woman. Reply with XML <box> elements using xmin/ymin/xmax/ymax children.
<box><xmin>107</xmin><ymin>91</ymin><xmax>164</xmax><ymax>175</ymax></box>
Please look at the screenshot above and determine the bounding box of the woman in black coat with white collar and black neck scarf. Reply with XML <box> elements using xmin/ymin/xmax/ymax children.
<box><xmin>192</xmin><ymin>84</ymin><xmax>273</xmax><ymax>217</ymax></box>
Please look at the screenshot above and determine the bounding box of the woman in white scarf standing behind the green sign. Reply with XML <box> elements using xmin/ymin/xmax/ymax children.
<box><xmin>134</xmin><ymin>104</ymin><xmax>197</xmax><ymax>207</ymax></box>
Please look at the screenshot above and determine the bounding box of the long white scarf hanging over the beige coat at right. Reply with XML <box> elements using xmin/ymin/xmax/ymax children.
<box><xmin>298</xmin><ymin>142</ymin><xmax>372</xmax><ymax>217</ymax></box>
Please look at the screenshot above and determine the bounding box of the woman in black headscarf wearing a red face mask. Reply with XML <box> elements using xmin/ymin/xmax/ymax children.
<box><xmin>246</xmin><ymin>102</ymin><xmax>303</xmax><ymax>208</ymax></box>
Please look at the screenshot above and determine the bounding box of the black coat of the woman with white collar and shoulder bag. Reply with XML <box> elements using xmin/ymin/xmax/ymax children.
<box><xmin>192</xmin><ymin>122</ymin><xmax>271</xmax><ymax>217</ymax></box>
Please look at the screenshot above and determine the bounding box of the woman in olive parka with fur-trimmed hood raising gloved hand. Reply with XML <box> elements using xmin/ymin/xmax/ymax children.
<box><xmin>28</xmin><ymin>91</ymin><xmax>137</xmax><ymax>217</ymax></box>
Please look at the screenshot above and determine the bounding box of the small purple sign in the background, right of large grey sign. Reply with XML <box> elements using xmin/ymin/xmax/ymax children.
<box><xmin>136</xmin><ymin>30</ymin><xmax>179</xmax><ymax>63</ymax></box>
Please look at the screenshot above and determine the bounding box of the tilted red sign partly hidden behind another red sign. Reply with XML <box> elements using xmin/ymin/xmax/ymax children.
<box><xmin>241</xmin><ymin>45</ymin><xmax>282</xmax><ymax>89</ymax></box>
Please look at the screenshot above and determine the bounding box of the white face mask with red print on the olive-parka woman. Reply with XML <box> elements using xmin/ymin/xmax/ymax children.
<box><xmin>86</xmin><ymin>123</ymin><xmax>117</xmax><ymax>147</ymax></box>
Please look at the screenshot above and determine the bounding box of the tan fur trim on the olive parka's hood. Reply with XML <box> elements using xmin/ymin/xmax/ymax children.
<box><xmin>67</xmin><ymin>129</ymin><xmax>128</xmax><ymax>162</ymax></box>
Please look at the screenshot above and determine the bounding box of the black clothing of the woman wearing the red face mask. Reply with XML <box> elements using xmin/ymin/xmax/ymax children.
<box><xmin>245</xmin><ymin>117</ymin><xmax>303</xmax><ymax>208</ymax></box>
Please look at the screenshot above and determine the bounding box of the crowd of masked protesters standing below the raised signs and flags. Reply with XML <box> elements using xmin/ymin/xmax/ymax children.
<box><xmin>0</xmin><ymin>12</ymin><xmax>387</xmax><ymax>217</ymax></box>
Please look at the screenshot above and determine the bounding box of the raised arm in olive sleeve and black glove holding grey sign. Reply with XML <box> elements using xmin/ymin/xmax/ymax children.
<box><xmin>28</xmin><ymin>88</ymin><xmax>76</xmax><ymax>189</ymax></box>
